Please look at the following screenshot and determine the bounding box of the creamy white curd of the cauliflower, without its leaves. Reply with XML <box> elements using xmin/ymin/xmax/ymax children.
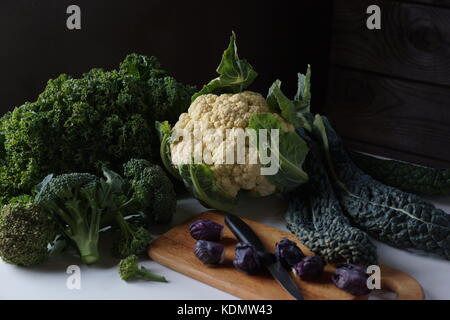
<box><xmin>170</xmin><ymin>91</ymin><xmax>294</xmax><ymax>197</ymax></box>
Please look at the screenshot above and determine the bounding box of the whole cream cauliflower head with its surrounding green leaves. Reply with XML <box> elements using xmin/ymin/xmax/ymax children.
<box><xmin>156</xmin><ymin>34</ymin><xmax>310</xmax><ymax>211</ymax></box>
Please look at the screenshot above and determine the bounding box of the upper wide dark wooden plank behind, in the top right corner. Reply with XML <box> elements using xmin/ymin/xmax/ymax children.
<box><xmin>331</xmin><ymin>0</ymin><xmax>450</xmax><ymax>86</ymax></box>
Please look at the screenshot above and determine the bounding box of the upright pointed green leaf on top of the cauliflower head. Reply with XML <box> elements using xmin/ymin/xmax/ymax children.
<box><xmin>192</xmin><ymin>32</ymin><xmax>258</xmax><ymax>101</ymax></box>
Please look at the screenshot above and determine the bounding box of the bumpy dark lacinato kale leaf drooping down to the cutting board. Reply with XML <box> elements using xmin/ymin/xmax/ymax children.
<box><xmin>286</xmin><ymin>129</ymin><xmax>377</xmax><ymax>266</ymax></box>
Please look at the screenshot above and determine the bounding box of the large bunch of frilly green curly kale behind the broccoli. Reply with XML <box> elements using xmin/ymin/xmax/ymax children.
<box><xmin>0</xmin><ymin>54</ymin><xmax>194</xmax><ymax>199</ymax></box>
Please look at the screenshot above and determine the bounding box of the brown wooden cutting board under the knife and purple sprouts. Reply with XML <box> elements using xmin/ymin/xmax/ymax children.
<box><xmin>148</xmin><ymin>211</ymin><xmax>424</xmax><ymax>300</ymax></box>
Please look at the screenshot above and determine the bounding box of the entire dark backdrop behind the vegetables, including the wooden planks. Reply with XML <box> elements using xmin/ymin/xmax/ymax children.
<box><xmin>0</xmin><ymin>0</ymin><xmax>450</xmax><ymax>168</ymax></box>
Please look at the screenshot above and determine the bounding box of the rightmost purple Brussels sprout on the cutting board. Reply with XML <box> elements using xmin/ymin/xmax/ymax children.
<box><xmin>331</xmin><ymin>264</ymin><xmax>370</xmax><ymax>296</ymax></box>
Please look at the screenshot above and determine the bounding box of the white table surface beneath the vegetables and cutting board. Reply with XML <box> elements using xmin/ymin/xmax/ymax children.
<box><xmin>0</xmin><ymin>197</ymin><xmax>450</xmax><ymax>300</ymax></box>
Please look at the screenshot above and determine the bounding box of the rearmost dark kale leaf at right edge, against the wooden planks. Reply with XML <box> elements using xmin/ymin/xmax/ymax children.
<box><xmin>351</xmin><ymin>152</ymin><xmax>450</xmax><ymax>195</ymax></box>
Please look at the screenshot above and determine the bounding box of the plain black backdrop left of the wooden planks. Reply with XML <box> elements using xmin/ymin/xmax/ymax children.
<box><xmin>0</xmin><ymin>0</ymin><xmax>332</xmax><ymax>112</ymax></box>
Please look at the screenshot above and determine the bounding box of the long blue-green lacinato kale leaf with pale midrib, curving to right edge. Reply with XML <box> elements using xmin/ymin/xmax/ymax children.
<box><xmin>315</xmin><ymin>116</ymin><xmax>450</xmax><ymax>259</ymax></box>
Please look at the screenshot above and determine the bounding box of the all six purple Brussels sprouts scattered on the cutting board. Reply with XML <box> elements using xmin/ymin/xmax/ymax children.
<box><xmin>189</xmin><ymin>220</ymin><xmax>370</xmax><ymax>296</ymax></box>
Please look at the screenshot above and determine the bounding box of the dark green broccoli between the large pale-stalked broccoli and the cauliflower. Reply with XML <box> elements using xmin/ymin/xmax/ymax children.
<box><xmin>100</xmin><ymin>159</ymin><xmax>176</xmax><ymax>258</ymax></box>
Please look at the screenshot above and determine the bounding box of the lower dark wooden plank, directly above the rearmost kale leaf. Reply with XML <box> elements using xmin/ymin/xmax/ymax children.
<box><xmin>325</xmin><ymin>68</ymin><xmax>450</xmax><ymax>167</ymax></box>
